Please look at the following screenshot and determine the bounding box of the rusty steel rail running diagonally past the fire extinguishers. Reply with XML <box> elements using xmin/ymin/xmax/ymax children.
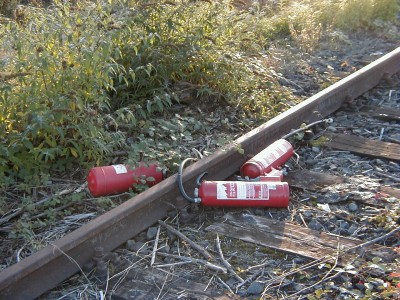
<box><xmin>0</xmin><ymin>47</ymin><xmax>400</xmax><ymax>299</ymax></box>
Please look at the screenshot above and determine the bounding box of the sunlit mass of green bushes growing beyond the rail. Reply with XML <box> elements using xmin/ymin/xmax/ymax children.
<box><xmin>0</xmin><ymin>0</ymin><xmax>399</xmax><ymax>185</ymax></box>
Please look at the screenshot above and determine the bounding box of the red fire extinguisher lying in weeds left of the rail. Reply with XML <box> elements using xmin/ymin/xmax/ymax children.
<box><xmin>87</xmin><ymin>164</ymin><xmax>164</xmax><ymax>197</ymax></box>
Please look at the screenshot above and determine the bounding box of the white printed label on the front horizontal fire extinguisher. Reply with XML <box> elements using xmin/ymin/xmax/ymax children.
<box><xmin>217</xmin><ymin>182</ymin><xmax>269</xmax><ymax>200</ymax></box>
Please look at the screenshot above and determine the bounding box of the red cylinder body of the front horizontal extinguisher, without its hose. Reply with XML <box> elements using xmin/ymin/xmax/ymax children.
<box><xmin>197</xmin><ymin>181</ymin><xmax>290</xmax><ymax>207</ymax></box>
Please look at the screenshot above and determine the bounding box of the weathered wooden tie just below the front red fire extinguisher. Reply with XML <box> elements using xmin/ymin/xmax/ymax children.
<box><xmin>206</xmin><ymin>213</ymin><xmax>399</xmax><ymax>266</ymax></box>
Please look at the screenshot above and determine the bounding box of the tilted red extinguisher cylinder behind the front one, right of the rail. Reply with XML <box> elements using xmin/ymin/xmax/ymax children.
<box><xmin>240</xmin><ymin>139</ymin><xmax>294</xmax><ymax>178</ymax></box>
